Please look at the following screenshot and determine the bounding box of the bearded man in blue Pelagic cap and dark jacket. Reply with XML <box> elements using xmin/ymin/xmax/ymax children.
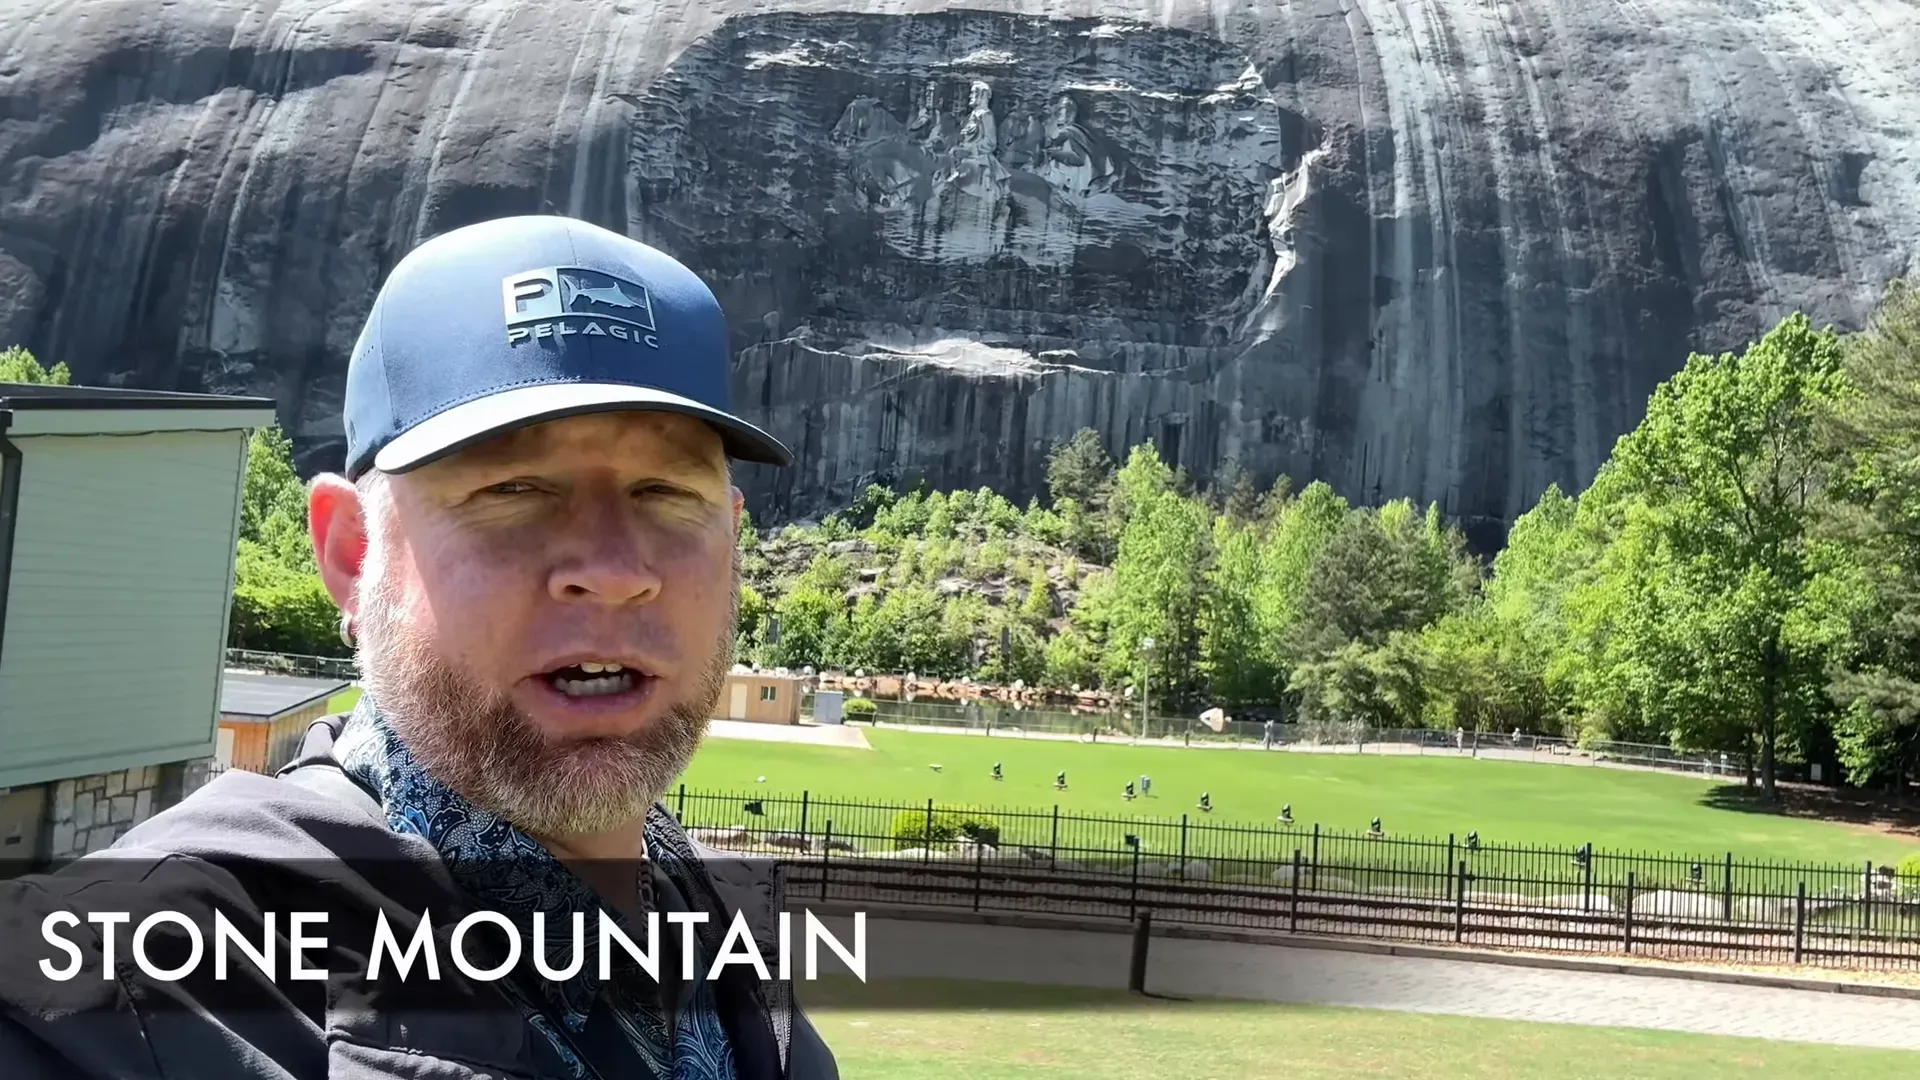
<box><xmin>0</xmin><ymin>217</ymin><xmax>837</xmax><ymax>1080</ymax></box>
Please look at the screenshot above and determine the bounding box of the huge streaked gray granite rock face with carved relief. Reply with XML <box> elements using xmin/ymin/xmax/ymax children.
<box><xmin>0</xmin><ymin>0</ymin><xmax>1920</xmax><ymax>542</ymax></box>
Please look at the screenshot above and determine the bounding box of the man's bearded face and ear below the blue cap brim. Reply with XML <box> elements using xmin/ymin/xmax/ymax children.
<box><xmin>313</xmin><ymin>413</ymin><xmax>739</xmax><ymax>836</ymax></box>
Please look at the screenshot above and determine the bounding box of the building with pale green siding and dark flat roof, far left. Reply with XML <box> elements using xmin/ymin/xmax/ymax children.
<box><xmin>0</xmin><ymin>384</ymin><xmax>273</xmax><ymax>869</ymax></box>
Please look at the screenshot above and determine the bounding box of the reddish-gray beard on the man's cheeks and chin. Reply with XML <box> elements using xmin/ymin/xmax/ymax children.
<box><xmin>355</xmin><ymin>557</ymin><xmax>739</xmax><ymax>836</ymax></box>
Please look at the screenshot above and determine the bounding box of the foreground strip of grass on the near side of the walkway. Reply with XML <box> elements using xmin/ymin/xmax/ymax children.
<box><xmin>801</xmin><ymin>978</ymin><xmax>1920</xmax><ymax>1080</ymax></box>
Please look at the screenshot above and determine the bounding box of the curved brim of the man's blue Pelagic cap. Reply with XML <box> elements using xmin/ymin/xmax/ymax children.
<box><xmin>372</xmin><ymin>382</ymin><xmax>793</xmax><ymax>473</ymax></box>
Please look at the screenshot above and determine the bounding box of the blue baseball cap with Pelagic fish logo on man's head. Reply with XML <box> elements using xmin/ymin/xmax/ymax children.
<box><xmin>346</xmin><ymin>215</ymin><xmax>793</xmax><ymax>479</ymax></box>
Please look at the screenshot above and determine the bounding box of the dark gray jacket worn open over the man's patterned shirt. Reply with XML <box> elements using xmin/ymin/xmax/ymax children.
<box><xmin>0</xmin><ymin>724</ymin><xmax>839</xmax><ymax>1080</ymax></box>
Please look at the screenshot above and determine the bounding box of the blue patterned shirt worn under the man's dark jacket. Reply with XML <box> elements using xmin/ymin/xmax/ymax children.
<box><xmin>334</xmin><ymin>698</ymin><xmax>735</xmax><ymax>1080</ymax></box>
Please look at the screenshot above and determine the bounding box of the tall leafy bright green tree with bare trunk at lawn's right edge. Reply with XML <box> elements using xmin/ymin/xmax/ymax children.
<box><xmin>1582</xmin><ymin>315</ymin><xmax>1847</xmax><ymax>799</ymax></box>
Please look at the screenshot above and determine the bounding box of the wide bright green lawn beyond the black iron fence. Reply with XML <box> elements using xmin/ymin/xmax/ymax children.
<box><xmin>684</xmin><ymin>728</ymin><xmax>1914</xmax><ymax>865</ymax></box>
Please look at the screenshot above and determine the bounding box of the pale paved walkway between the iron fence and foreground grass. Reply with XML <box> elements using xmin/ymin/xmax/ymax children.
<box><xmin>829</xmin><ymin>917</ymin><xmax>1920</xmax><ymax>1045</ymax></box>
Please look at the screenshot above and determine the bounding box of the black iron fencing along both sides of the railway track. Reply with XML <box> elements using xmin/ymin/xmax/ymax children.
<box><xmin>670</xmin><ymin>788</ymin><xmax>1920</xmax><ymax>970</ymax></box>
